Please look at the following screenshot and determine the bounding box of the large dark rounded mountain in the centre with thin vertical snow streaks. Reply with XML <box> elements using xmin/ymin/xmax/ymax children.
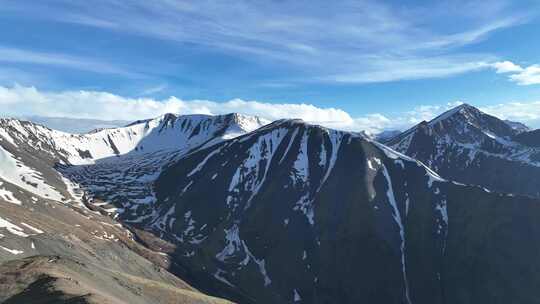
<box><xmin>123</xmin><ymin>121</ymin><xmax>540</xmax><ymax>303</ymax></box>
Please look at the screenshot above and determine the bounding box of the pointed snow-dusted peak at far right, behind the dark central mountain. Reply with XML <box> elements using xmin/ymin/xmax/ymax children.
<box><xmin>385</xmin><ymin>104</ymin><xmax>540</xmax><ymax>197</ymax></box>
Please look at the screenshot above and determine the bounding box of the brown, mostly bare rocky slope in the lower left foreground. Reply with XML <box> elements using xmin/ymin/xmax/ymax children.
<box><xmin>0</xmin><ymin>177</ymin><xmax>232</xmax><ymax>304</ymax></box>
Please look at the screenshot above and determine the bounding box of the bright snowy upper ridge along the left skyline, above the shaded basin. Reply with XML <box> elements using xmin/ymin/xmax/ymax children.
<box><xmin>0</xmin><ymin>114</ymin><xmax>267</xmax><ymax>164</ymax></box>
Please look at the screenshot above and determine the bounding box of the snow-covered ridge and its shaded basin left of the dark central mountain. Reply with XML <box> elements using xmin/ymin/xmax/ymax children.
<box><xmin>0</xmin><ymin>114</ymin><xmax>267</xmax><ymax>208</ymax></box>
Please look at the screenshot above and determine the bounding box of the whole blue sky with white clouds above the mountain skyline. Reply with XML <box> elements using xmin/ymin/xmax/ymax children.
<box><xmin>0</xmin><ymin>0</ymin><xmax>540</xmax><ymax>129</ymax></box>
